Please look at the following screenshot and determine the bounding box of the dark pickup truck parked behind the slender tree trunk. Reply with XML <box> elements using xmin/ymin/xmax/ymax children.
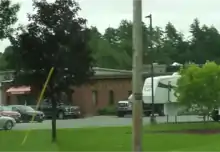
<box><xmin>32</xmin><ymin>99</ymin><xmax>81</xmax><ymax>119</ymax></box>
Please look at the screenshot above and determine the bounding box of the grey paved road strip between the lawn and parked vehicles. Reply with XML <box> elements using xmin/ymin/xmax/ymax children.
<box><xmin>14</xmin><ymin>116</ymin><xmax>209</xmax><ymax>130</ymax></box>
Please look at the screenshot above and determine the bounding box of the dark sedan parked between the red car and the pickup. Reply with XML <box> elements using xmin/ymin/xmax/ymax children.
<box><xmin>9</xmin><ymin>105</ymin><xmax>45</xmax><ymax>122</ymax></box>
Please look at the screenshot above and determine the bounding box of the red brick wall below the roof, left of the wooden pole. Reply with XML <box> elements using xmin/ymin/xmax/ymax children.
<box><xmin>72</xmin><ymin>78</ymin><xmax>131</xmax><ymax>115</ymax></box>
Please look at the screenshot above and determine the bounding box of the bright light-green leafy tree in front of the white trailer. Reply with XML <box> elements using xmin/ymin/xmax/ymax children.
<box><xmin>176</xmin><ymin>62</ymin><xmax>220</xmax><ymax>118</ymax></box>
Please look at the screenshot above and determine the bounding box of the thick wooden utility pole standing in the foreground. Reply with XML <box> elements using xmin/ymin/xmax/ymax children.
<box><xmin>132</xmin><ymin>0</ymin><xmax>143</xmax><ymax>152</ymax></box>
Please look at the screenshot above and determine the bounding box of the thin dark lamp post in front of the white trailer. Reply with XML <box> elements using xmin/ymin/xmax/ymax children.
<box><xmin>145</xmin><ymin>14</ymin><xmax>156</xmax><ymax>124</ymax></box>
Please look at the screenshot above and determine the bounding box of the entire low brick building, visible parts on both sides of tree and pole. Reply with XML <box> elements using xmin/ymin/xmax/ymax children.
<box><xmin>1</xmin><ymin>66</ymin><xmax>171</xmax><ymax>115</ymax></box>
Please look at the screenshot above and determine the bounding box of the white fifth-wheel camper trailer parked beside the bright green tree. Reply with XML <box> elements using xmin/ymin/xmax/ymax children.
<box><xmin>124</xmin><ymin>73</ymin><xmax>183</xmax><ymax>115</ymax></box>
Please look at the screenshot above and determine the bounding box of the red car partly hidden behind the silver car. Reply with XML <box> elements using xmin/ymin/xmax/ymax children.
<box><xmin>0</xmin><ymin>106</ymin><xmax>21</xmax><ymax>123</ymax></box>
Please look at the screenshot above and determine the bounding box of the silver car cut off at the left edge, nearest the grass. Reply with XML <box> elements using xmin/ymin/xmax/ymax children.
<box><xmin>0</xmin><ymin>115</ymin><xmax>16</xmax><ymax>130</ymax></box>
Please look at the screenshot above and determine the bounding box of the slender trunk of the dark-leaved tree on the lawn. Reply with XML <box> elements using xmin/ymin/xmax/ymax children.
<box><xmin>52</xmin><ymin>97</ymin><xmax>57</xmax><ymax>142</ymax></box>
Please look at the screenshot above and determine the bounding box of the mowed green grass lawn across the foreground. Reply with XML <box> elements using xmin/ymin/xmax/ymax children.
<box><xmin>0</xmin><ymin>123</ymin><xmax>220</xmax><ymax>152</ymax></box>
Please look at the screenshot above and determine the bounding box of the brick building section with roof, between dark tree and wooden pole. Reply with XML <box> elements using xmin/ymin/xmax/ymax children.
<box><xmin>72</xmin><ymin>68</ymin><xmax>131</xmax><ymax>115</ymax></box>
